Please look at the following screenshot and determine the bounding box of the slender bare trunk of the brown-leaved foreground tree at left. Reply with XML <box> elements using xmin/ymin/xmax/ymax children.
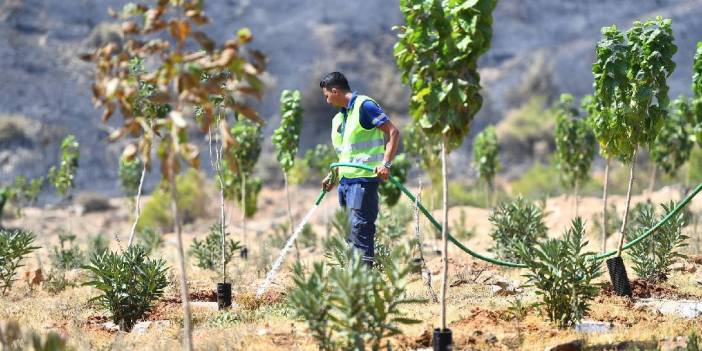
<box><xmin>168</xmin><ymin>155</ymin><xmax>193</xmax><ymax>351</ymax></box>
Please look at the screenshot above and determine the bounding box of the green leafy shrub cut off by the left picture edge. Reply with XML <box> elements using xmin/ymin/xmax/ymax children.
<box><xmin>0</xmin><ymin>229</ymin><xmax>39</xmax><ymax>295</ymax></box>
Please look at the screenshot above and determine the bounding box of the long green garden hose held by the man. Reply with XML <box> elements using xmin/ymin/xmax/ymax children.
<box><xmin>315</xmin><ymin>162</ymin><xmax>702</xmax><ymax>268</ymax></box>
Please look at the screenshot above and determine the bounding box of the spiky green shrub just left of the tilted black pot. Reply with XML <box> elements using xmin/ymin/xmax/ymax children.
<box><xmin>517</xmin><ymin>217</ymin><xmax>602</xmax><ymax>328</ymax></box>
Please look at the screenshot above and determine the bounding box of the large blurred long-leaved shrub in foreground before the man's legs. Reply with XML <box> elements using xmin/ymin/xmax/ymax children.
<box><xmin>290</xmin><ymin>237</ymin><xmax>420</xmax><ymax>350</ymax></box>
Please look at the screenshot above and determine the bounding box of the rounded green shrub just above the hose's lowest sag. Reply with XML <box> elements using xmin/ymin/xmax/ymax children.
<box><xmin>489</xmin><ymin>196</ymin><xmax>546</xmax><ymax>261</ymax></box>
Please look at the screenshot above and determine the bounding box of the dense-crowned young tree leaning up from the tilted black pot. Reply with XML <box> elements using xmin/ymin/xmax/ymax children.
<box><xmin>592</xmin><ymin>17</ymin><xmax>677</xmax><ymax>257</ymax></box>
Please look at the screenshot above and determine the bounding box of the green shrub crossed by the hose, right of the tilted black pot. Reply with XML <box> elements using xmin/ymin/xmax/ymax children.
<box><xmin>627</xmin><ymin>201</ymin><xmax>688</xmax><ymax>282</ymax></box>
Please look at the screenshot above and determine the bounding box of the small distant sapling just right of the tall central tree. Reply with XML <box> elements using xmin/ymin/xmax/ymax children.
<box><xmin>473</xmin><ymin>126</ymin><xmax>500</xmax><ymax>208</ymax></box>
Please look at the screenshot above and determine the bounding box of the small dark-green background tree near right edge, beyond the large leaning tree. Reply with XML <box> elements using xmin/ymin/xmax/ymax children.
<box><xmin>648</xmin><ymin>96</ymin><xmax>694</xmax><ymax>192</ymax></box>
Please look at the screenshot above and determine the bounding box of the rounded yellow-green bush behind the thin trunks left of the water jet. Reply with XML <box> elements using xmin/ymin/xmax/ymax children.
<box><xmin>137</xmin><ymin>169</ymin><xmax>207</xmax><ymax>231</ymax></box>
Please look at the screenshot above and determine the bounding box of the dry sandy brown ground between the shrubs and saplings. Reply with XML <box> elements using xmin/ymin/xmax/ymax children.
<box><xmin>0</xmin><ymin>188</ymin><xmax>702</xmax><ymax>350</ymax></box>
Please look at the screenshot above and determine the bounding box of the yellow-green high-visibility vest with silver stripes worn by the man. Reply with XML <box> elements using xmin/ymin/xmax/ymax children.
<box><xmin>331</xmin><ymin>95</ymin><xmax>385</xmax><ymax>178</ymax></box>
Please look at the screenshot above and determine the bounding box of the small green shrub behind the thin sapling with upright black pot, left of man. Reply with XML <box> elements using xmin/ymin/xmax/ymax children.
<box><xmin>190</xmin><ymin>223</ymin><xmax>241</xmax><ymax>271</ymax></box>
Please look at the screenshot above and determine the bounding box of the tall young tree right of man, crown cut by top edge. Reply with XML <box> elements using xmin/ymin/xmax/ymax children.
<box><xmin>394</xmin><ymin>0</ymin><xmax>497</xmax><ymax>338</ymax></box>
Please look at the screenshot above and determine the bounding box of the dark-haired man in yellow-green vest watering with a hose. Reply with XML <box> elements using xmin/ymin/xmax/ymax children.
<box><xmin>319</xmin><ymin>72</ymin><xmax>400</xmax><ymax>265</ymax></box>
